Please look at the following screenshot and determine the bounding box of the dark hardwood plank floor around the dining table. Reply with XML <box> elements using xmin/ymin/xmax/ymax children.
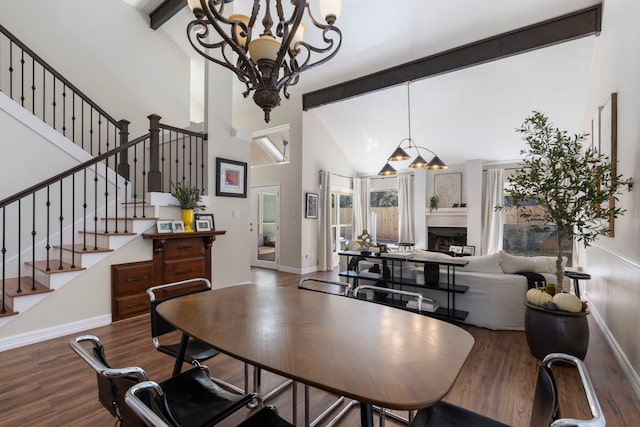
<box><xmin>0</xmin><ymin>269</ymin><xmax>640</xmax><ymax>427</ymax></box>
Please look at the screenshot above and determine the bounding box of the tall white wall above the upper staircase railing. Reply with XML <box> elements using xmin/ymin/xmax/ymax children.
<box><xmin>0</xmin><ymin>0</ymin><xmax>190</xmax><ymax>137</ymax></box>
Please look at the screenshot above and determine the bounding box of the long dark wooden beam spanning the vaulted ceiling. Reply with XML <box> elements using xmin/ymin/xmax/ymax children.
<box><xmin>302</xmin><ymin>4</ymin><xmax>602</xmax><ymax>111</ymax></box>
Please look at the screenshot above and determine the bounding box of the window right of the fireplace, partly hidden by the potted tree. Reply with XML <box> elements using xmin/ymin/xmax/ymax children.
<box><xmin>502</xmin><ymin>193</ymin><xmax>573</xmax><ymax>266</ymax></box>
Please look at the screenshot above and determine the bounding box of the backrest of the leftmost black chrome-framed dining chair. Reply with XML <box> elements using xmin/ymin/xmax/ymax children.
<box><xmin>69</xmin><ymin>335</ymin><xmax>147</xmax><ymax>427</ymax></box>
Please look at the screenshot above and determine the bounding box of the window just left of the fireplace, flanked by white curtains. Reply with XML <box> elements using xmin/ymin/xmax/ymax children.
<box><xmin>370</xmin><ymin>190</ymin><xmax>398</xmax><ymax>243</ymax></box>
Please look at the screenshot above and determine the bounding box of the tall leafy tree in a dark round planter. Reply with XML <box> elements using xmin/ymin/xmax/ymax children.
<box><xmin>496</xmin><ymin>111</ymin><xmax>632</xmax><ymax>358</ymax></box>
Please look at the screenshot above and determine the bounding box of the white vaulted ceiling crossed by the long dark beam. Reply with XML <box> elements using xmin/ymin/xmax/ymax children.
<box><xmin>123</xmin><ymin>0</ymin><xmax>598</xmax><ymax>175</ymax></box>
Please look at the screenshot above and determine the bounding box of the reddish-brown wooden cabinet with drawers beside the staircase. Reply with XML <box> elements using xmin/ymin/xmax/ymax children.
<box><xmin>111</xmin><ymin>231</ymin><xmax>226</xmax><ymax>321</ymax></box>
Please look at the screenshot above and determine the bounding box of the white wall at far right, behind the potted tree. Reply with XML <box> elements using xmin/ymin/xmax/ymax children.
<box><xmin>583</xmin><ymin>0</ymin><xmax>640</xmax><ymax>394</ymax></box>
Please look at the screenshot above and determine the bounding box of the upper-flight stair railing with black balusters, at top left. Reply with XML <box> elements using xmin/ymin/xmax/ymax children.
<box><xmin>0</xmin><ymin>25</ymin><xmax>128</xmax><ymax>155</ymax></box>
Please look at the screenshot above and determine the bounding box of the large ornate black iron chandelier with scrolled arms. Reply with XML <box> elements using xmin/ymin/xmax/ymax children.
<box><xmin>187</xmin><ymin>0</ymin><xmax>342</xmax><ymax>122</ymax></box>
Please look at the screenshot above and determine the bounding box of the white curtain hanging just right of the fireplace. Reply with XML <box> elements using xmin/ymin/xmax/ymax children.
<box><xmin>482</xmin><ymin>169</ymin><xmax>504</xmax><ymax>254</ymax></box>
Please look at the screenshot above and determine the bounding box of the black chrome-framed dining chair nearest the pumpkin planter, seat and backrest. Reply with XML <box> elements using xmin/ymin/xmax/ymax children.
<box><xmin>410</xmin><ymin>353</ymin><xmax>606</xmax><ymax>427</ymax></box>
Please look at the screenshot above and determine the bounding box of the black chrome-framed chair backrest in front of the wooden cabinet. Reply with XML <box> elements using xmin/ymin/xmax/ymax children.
<box><xmin>147</xmin><ymin>278</ymin><xmax>212</xmax><ymax>347</ymax></box>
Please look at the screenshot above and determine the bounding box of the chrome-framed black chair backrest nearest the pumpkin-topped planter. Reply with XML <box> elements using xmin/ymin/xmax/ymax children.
<box><xmin>530</xmin><ymin>353</ymin><xmax>606</xmax><ymax>427</ymax></box>
